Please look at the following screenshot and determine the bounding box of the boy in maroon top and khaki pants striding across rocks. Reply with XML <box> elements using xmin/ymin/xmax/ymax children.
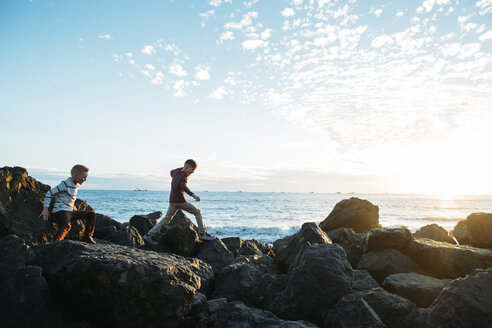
<box><xmin>143</xmin><ymin>159</ymin><xmax>215</xmax><ymax>245</ymax></box>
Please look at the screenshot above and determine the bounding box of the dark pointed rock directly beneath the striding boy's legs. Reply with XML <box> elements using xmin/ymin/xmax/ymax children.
<box><xmin>161</xmin><ymin>211</ymin><xmax>200</xmax><ymax>256</ymax></box>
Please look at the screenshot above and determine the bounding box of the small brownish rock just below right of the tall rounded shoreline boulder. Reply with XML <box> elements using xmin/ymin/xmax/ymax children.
<box><xmin>363</xmin><ymin>227</ymin><xmax>413</xmax><ymax>252</ymax></box>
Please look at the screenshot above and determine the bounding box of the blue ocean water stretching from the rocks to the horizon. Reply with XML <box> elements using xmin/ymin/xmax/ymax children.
<box><xmin>77</xmin><ymin>189</ymin><xmax>492</xmax><ymax>243</ymax></box>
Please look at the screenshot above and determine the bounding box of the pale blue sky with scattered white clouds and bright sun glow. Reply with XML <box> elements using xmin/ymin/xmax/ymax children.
<box><xmin>0</xmin><ymin>0</ymin><xmax>492</xmax><ymax>195</ymax></box>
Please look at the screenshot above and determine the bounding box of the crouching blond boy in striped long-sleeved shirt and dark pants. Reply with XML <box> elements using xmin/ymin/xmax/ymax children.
<box><xmin>40</xmin><ymin>164</ymin><xmax>96</xmax><ymax>244</ymax></box>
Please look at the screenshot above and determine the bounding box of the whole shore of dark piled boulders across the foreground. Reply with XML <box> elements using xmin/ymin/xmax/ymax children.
<box><xmin>0</xmin><ymin>167</ymin><xmax>492</xmax><ymax>328</ymax></box>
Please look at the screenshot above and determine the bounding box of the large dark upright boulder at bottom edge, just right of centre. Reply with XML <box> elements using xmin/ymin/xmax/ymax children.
<box><xmin>268</xmin><ymin>243</ymin><xmax>353</xmax><ymax>324</ymax></box>
